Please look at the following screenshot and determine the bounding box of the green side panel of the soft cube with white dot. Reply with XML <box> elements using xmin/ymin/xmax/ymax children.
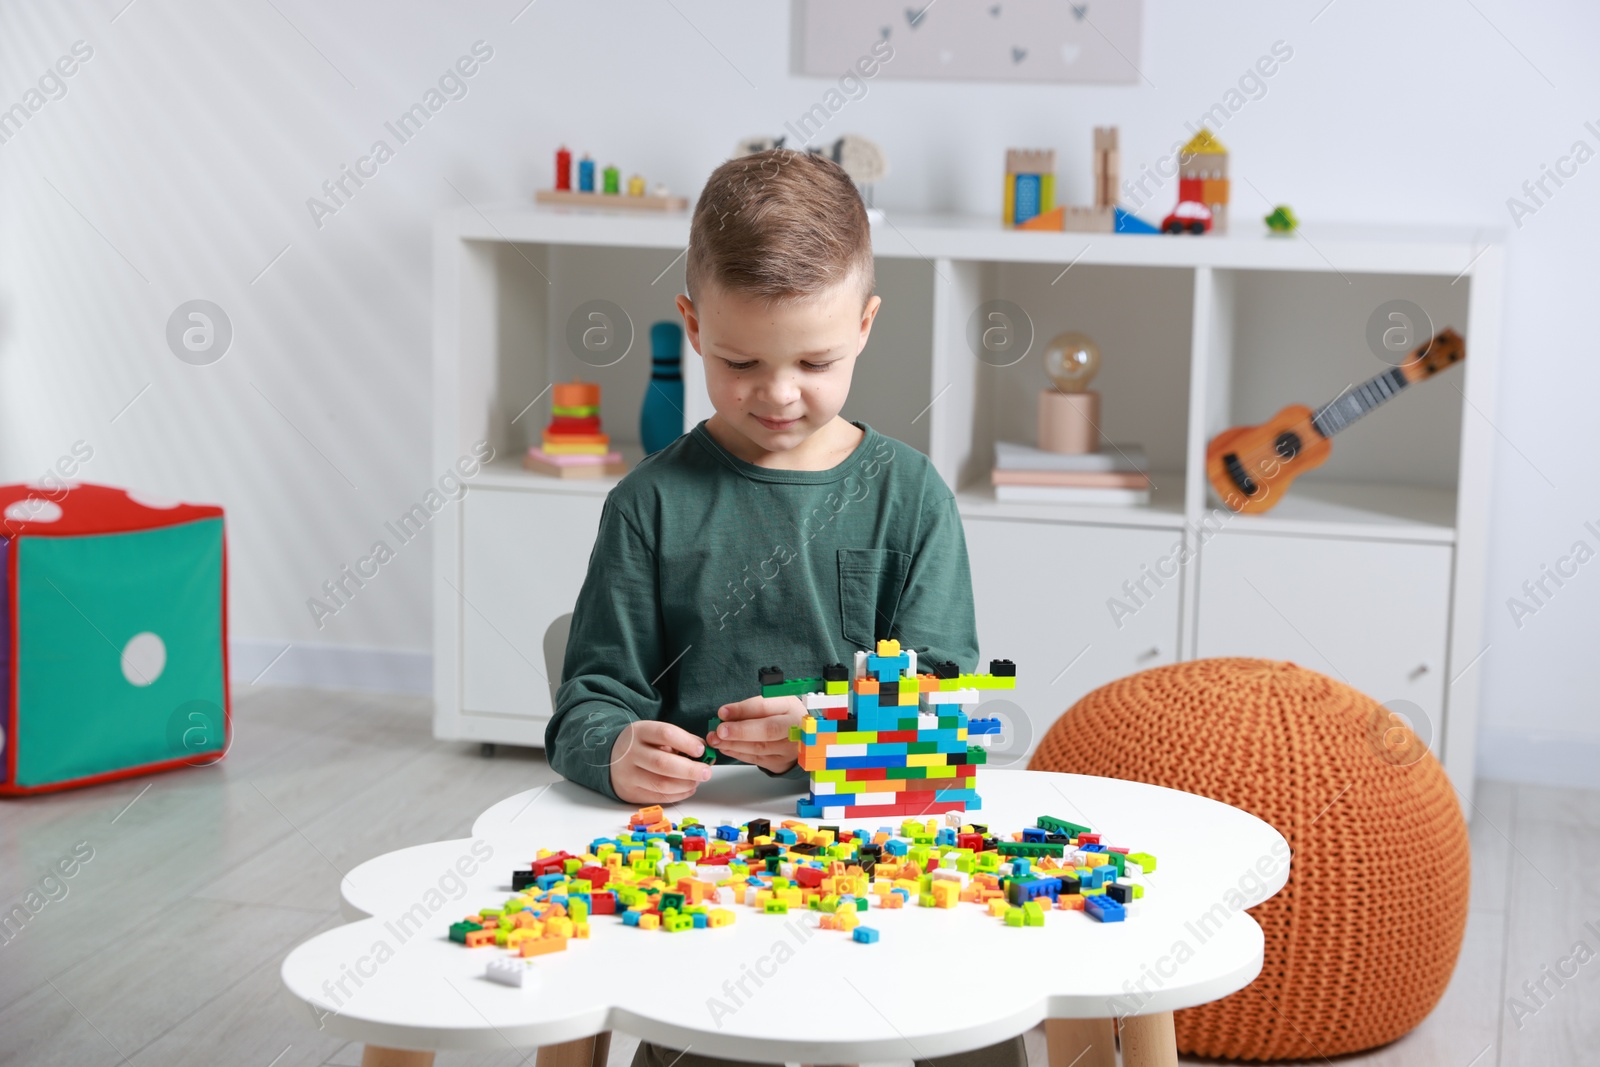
<box><xmin>14</xmin><ymin>518</ymin><xmax>227</xmax><ymax>785</ymax></box>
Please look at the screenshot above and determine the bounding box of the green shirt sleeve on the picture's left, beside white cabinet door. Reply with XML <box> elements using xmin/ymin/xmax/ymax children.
<box><xmin>544</xmin><ymin>496</ymin><xmax>666</xmax><ymax>800</ymax></box>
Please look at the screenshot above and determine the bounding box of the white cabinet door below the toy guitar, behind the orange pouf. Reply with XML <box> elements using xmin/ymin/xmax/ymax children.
<box><xmin>1197</xmin><ymin>530</ymin><xmax>1453</xmax><ymax>753</ymax></box>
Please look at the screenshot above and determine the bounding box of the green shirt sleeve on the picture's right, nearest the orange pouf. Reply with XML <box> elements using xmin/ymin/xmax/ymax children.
<box><xmin>894</xmin><ymin>482</ymin><xmax>978</xmax><ymax>672</ymax></box>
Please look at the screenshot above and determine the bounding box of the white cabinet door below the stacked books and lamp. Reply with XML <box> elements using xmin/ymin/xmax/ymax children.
<box><xmin>965</xmin><ymin>517</ymin><xmax>1182</xmax><ymax>766</ymax></box>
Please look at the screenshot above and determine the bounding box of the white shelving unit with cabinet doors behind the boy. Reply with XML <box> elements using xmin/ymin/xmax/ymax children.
<box><xmin>434</xmin><ymin>206</ymin><xmax>1504</xmax><ymax>806</ymax></box>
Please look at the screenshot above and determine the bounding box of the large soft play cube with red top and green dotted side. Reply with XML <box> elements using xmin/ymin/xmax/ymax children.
<box><xmin>0</xmin><ymin>483</ymin><xmax>232</xmax><ymax>795</ymax></box>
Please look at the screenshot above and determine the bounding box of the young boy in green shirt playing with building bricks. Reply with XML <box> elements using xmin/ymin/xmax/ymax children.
<box><xmin>546</xmin><ymin>149</ymin><xmax>1022</xmax><ymax>1067</ymax></box>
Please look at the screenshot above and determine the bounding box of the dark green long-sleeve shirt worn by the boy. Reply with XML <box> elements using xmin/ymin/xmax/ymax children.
<box><xmin>544</xmin><ymin>422</ymin><xmax>978</xmax><ymax>798</ymax></box>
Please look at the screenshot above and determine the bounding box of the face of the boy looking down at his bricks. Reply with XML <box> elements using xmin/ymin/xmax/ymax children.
<box><xmin>678</xmin><ymin>280</ymin><xmax>882</xmax><ymax>456</ymax></box>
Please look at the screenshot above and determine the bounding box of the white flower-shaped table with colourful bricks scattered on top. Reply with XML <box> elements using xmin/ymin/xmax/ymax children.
<box><xmin>283</xmin><ymin>766</ymin><xmax>1290</xmax><ymax>1067</ymax></box>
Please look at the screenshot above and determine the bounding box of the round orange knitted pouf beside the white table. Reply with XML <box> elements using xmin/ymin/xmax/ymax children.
<box><xmin>1029</xmin><ymin>659</ymin><xmax>1470</xmax><ymax>1059</ymax></box>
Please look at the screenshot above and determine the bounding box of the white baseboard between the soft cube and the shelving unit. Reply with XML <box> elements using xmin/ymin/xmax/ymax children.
<box><xmin>227</xmin><ymin>640</ymin><xmax>434</xmax><ymax>693</ymax></box>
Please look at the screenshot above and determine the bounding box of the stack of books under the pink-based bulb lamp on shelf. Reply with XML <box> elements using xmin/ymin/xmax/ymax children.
<box><xmin>990</xmin><ymin>442</ymin><xmax>1150</xmax><ymax>504</ymax></box>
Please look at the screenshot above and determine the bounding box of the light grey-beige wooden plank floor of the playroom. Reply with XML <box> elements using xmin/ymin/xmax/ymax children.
<box><xmin>0</xmin><ymin>688</ymin><xmax>1600</xmax><ymax>1067</ymax></box>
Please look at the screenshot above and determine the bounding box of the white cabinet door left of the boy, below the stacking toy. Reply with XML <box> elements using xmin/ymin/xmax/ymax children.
<box><xmin>461</xmin><ymin>490</ymin><xmax>605</xmax><ymax>736</ymax></box>
